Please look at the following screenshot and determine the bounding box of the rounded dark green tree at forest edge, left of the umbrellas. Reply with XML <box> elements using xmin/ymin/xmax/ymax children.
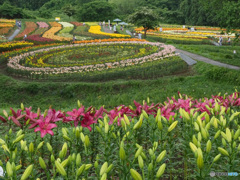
<box><xmin>77</xmin><ymin>1</ymin><xmax>115</xmax><ymax>21</ymax></box>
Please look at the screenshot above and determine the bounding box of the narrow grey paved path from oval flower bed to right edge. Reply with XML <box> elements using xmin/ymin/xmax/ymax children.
<box><xmin>176</xmin><ymin>49</ymin><xmax>240</xmax><ymax>70</ymax></box>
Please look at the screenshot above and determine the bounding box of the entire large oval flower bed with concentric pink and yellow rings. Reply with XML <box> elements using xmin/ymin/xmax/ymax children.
<box><xmin>5</xmin><ymin>41</ymin><xmax>187</xmax><ymax>81</ymax></box>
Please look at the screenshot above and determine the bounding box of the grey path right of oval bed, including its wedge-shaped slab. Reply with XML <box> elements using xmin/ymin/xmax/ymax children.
<box><xmin>176</xmin><ymin>49</ymin><xmax>240</xmax><ymax>70</ymax></box>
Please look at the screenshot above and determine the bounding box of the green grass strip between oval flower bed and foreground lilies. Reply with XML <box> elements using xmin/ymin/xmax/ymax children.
<box><xmin>0</xmin><ymin>62</ymin><xmax>240</xmax><ymax>109</ymax></box>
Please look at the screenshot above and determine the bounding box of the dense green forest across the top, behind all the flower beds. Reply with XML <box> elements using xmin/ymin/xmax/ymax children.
<box><xmin>0</xmin><ymin>0</ymin><xmax>240</xmax><ymax>29</ymax></box>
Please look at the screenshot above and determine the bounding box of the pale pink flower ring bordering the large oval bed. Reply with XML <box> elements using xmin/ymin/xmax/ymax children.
<box><xmin>8</xmin><ymin>42</ymin><xmax>175</xmax><ymax>74</ymax></box>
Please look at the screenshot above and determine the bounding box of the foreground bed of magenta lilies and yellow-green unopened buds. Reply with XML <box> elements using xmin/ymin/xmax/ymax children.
<box><xmin>0</xmin><ymin>92</ymin><xmax>240</xmax><ymax>180</ymax></box>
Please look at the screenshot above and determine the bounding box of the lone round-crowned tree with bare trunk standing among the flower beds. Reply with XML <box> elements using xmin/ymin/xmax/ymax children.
<box><xmin>128</xmin><ymin>7</ymin><xmax>158</xmax><ymax>38</ymax></box>
